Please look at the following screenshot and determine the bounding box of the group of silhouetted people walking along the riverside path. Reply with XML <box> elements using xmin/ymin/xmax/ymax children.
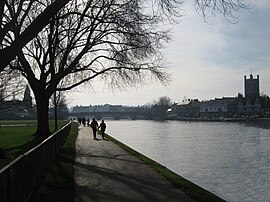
<box><xmin>78</xmin><ymin>118</ymin><xmax>106</xmax><ymax>140</ymax></box>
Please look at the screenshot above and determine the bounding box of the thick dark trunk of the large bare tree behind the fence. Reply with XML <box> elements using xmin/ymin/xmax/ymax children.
<box><xmin>36</xmin><ymin>95</ymin><xmax>50</xmax><ymax>137</ymax></box>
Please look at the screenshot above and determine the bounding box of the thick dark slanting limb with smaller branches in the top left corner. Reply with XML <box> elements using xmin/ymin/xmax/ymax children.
<box><xmin>0</xmin><ymin>0</ymin><xmax>69</xmax><ymax>71</ymax></box>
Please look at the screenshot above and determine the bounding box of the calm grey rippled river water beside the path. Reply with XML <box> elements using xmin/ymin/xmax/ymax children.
<box><xmin>105</xmin><ymin>120</ymin><xmax>270</xmax><ymax>202</ymax></box>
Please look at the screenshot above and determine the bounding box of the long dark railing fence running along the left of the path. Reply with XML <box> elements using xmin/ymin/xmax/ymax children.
<box><xmin>0</xmin><ymin>123</ymin><xmax>71</xmax><ymax>202</ymax></box>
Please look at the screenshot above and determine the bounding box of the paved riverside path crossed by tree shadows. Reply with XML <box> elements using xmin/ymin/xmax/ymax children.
<box><xmin>75</xmin><ymin>126</ymin><xmax>193</xmax><ymax>202</ymax></box>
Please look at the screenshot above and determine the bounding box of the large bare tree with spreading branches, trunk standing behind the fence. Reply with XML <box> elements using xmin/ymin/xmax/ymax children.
<box><xmin>10</xmin><ymin>0</ymin><xmax>251</xmax><ymax>136</ymax></box>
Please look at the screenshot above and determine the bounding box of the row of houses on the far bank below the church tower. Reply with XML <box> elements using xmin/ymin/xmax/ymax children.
<box><xmin>168</xmin><ymin>97</ymin><xmax>270</xmax><ymax>118</ymax></box>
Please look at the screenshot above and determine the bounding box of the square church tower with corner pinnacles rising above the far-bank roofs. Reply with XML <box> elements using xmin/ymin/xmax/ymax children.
<box><xmin>244</xmin><ymin>74</ymin><xmax>260</xmax><ymax>99</ymax></box>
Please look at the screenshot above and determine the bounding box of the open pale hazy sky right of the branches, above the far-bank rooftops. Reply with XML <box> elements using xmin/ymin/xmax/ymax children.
<box><xmin>68</xmin><ymin>0</ymin><xmax>270</xmax><ymax>106</ymax></box>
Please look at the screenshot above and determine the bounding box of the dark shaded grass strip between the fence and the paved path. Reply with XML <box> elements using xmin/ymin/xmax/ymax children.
<box><xmin>29</xmin><ymin>123</ymin><xmax>78</xmax><ymax>202</ymax></box>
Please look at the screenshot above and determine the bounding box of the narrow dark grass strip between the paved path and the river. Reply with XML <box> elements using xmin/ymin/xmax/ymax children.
<box><xmin>105</xmin><ymin>134</ymin><xmax>225</xmax><ymax>202</ymax></box>
